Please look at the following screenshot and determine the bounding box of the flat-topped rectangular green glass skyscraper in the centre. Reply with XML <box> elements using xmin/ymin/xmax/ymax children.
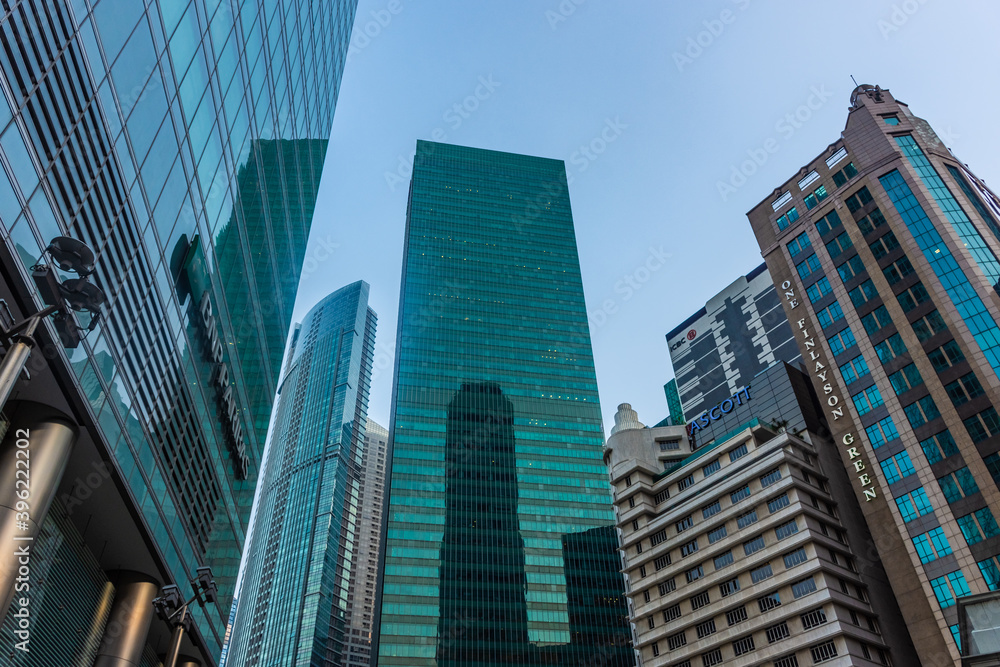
<box><xmin>376</xmin><ymin>141</ymin><xmax>634</xmax><ymax>667</ymax></box>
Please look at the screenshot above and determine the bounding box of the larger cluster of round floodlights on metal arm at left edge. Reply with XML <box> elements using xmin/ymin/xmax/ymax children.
<box><xmin>0</xmin><ymin>236</ymin><xmax>105</xmax><ymax>409</ymax></box>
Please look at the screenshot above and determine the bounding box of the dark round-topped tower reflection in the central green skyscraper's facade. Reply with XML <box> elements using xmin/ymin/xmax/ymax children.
<box><xmin>438</xmin><ymin>382</ymin><xmax>529</xmax><ymax>667</ymax></box>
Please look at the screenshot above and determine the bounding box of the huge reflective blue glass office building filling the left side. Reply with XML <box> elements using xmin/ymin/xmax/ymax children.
<box><xmin>0</xmin><ymin>0</ymin><xmax>356</xmax><ymax>666</ymax></box>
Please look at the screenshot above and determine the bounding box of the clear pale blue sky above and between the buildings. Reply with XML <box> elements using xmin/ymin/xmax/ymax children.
<box><xmin>295</xmin><ymin>0</ymin><xmax>1000</xmax><ymax>430</ymax></box>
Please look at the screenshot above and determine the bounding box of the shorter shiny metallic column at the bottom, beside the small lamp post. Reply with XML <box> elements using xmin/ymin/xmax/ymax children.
<box><xmin>94</xmin><ymin>570</ymin><xmax>160</xmax><ymax>667</ymax></box>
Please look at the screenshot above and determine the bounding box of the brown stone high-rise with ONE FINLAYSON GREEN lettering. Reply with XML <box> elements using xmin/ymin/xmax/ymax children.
<box><xmin>748</xmin><ymin>85</ymin><xmax>1000</xmax><ymax>665</ymax></box>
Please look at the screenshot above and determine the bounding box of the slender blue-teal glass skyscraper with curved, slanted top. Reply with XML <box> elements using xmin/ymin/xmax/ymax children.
<box><xmin>227</xmin><ymin>282</ymin><xmax>376</xmax><ymax>667</ymax></box>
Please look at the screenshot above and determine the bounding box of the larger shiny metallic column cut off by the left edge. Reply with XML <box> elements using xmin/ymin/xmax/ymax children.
<box><xmin>0</xmin><ymin>401</ymin><xmax>77</xmax><ymax>622</ymax></box>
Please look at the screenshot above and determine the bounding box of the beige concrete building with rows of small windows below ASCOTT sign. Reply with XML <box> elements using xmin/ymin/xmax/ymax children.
<box><xmin>605</xmin><ymin>396</ymin><xmax>917</xmax><ymax>667</ymax></box>
